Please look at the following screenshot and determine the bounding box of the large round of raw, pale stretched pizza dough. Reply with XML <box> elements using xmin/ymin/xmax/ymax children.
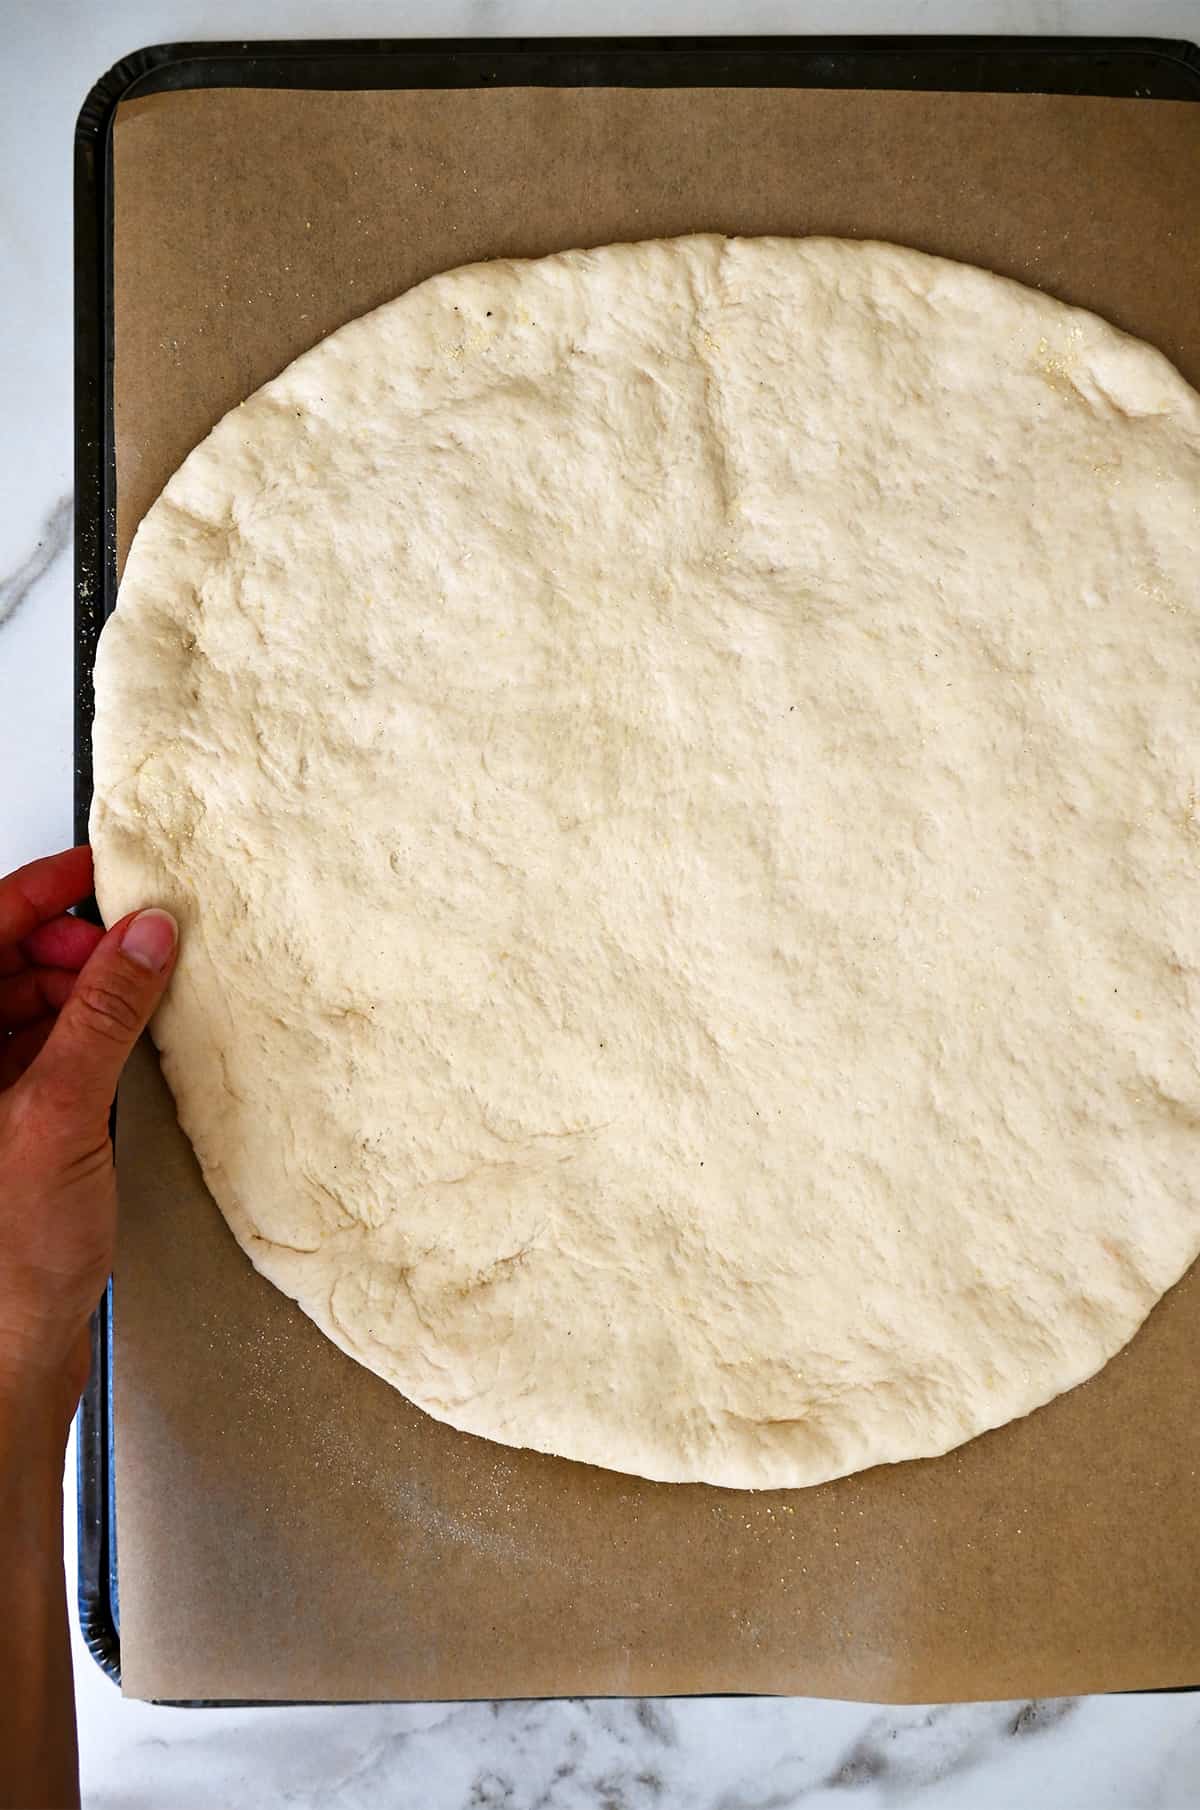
<box><xmin>92</xmin><ymin>235</ymin><xmax>1200</xmax><ymax>1488</ymax></box>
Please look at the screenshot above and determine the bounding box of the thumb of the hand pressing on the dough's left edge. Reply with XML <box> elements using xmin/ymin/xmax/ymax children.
<box><xmin>27</xmin><ymin>907</ymin><xmax>179</xmax><ymax>1120</ymax></box>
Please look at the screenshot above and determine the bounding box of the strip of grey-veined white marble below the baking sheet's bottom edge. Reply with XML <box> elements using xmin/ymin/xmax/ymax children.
<box><xmin>77</xmin><ymin>1698</ymin><xmax>1200</xmax><ymax>1810</ymax></box>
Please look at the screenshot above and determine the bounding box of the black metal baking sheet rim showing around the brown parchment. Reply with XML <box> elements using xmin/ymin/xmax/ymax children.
<box><xmin>74</xmin><ymin>38</ymin><xmax>1200</xmax><ymax>1683</ymax></box>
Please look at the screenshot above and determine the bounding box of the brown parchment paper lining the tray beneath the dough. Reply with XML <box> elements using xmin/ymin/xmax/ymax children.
<box><xmin>114</xmin><ymin>89</ymin><xmax>1200</xmax><ymax>1701</ymax></box>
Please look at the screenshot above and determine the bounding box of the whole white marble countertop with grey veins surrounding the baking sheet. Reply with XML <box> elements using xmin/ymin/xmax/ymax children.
<box><xmin>0</xmin><ymin>0</ymin><xmax>1200</xmax><ymax>1810</ymax></box>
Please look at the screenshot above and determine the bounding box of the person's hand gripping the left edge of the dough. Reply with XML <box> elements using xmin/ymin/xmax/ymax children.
<box><xmin>0</xmin><ymin>847</ymin><xmax>177</xmax><ymax>1432</ymax></box>
